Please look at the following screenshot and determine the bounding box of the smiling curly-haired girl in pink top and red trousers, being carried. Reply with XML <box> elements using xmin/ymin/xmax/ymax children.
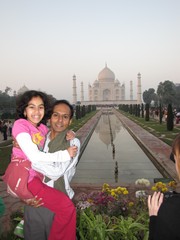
<box><xmin>5</xmin><ymin>90</ymin><xmax>77</xmax><ymax>240</ymax></box>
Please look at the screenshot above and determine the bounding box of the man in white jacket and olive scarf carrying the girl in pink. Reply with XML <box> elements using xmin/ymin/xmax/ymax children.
<box><xmin>24</xmin><ymin>100</ymin><xmax>80</xmax><ymax>240</ymax></box>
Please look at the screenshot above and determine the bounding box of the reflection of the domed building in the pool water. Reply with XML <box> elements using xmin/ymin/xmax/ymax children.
<box><xmin>95</xmin><ymin>113</ymin><xmax>121</xmax><ymax>147</ymax></box>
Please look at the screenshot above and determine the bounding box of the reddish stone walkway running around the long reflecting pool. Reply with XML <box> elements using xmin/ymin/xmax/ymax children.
<box><xmin>0</xmin><ymin>112</ymin><xmax>177</xmax><ymax>235</ymax></box>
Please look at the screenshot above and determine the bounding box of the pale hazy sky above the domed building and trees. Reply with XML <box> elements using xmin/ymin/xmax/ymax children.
<box><xmin>0</xmin><ymin>0</ymin><xmax>180</xmax><ymax>102</ymax></box>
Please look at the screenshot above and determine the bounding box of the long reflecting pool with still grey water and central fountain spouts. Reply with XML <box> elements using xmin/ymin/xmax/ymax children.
<box><xmin>73</xmin><ymin>111</ymin><xmax>162</xmax><ymax>184</ymax></box>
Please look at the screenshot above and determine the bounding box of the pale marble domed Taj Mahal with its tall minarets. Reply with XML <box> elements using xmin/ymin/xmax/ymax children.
<box><xmin>73</xmin><ymin>64</ymin><xmax>142</xmax><ymax>105</ymax></box>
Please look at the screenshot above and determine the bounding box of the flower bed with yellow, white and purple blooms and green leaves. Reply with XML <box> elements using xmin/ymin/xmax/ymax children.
<box><xmin>76</xmin><ymin>179</ymin><xmax>175</xmax><ymax>240</ymax></box>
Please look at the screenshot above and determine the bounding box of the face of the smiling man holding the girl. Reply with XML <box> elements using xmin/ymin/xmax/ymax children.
<box><xmin>50</xmin><ymin>103</ymin><xmax>71</xmax><ymax>134</ymax></box>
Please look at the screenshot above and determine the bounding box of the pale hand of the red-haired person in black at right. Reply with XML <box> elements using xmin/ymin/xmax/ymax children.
<box><xmin>148</xmin><ymin>192</ymin><xmax>164</xmax><ymax>216</ymax></box>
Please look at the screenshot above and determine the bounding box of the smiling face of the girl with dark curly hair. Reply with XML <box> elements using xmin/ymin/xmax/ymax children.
<box><xmin>24</xmin><ymin>97</ymin><xmax>45</xmax><ymax>126</ymax></box>
